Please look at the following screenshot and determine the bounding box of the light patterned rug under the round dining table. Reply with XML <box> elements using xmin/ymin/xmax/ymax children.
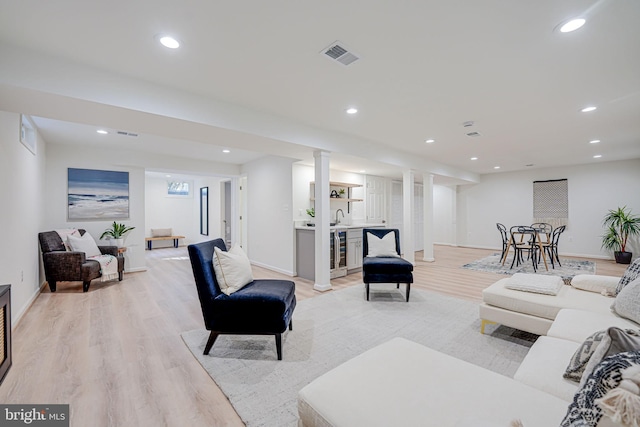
<box><xmin>462</xmin><ymin>251</ymin><xmax>596</xmax><ymax>282</ymax></box>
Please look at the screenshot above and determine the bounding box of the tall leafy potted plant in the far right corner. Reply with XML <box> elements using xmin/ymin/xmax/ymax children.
<box><xmin>602</xmin><ymin>206</ymin><xmax>640</xmax><ymax>264</ymax></box>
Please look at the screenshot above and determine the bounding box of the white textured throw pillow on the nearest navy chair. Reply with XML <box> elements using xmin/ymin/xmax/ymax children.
<box><xmin>213</xmin><ymin>245</ymin><xmax>253</xmax><ymax>295</ymax></box>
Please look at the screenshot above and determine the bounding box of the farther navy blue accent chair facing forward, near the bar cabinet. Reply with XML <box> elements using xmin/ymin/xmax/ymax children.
<box><xmin>362</xmin><ymin>228</ymin><xmax>413</xmax><ymax>302</ymax></box>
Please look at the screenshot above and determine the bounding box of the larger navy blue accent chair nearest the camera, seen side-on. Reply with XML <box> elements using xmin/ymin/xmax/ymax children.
<box><xmin>187</xmin><ymin>239</ymin><xmax>296</xmax><ymax>360</ymax></box>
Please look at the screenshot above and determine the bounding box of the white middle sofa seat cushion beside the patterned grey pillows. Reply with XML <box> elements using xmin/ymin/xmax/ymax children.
<box><xmin>513</xmin><ymin>337</ymin><xmax>580</xmax><ymax>402</ymax></box>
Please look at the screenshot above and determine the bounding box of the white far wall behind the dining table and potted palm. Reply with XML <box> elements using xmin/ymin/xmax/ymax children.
<box><xmin>448</xmin><ymin>159</ymin><xmax>640</xmax><ymax>258</ymax></box>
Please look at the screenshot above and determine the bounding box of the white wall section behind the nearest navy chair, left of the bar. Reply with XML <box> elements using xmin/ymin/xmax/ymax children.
<box><xmin>242</xmin><ymin>156</ymin><xmax>296</xmax><ymax>275</ymax></box>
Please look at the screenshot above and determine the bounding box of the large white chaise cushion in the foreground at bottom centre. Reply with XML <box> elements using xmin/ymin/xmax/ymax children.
<box><xmin>298</xmin><ymin>338</ymin><xmax>567</xmax><ymax>427</ymax></box>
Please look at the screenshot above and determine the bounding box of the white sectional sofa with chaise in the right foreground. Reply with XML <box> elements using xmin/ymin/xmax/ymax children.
<box><xmin>298</xmin><ymin>270</ymin><xmax>640</xmax><ymax>427</ymax></box>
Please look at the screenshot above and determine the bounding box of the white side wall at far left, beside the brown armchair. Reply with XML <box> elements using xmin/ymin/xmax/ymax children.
<box><xmin>0</xmin><ymin>111</ymin><xmax>49</xmax><ymax>326</ymax></box>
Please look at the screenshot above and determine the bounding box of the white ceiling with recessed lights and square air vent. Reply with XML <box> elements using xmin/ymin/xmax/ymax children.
<box><xmin>0</xmin><ymin>0</ymin><xmax>640</xmax><ymax>182</ymax></box>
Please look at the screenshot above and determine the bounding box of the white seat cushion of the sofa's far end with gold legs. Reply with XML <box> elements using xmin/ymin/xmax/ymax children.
<box><xmin>482</xmin><ymin>278</ymin><xmax>613</xmax><ymax>320</ymax></box>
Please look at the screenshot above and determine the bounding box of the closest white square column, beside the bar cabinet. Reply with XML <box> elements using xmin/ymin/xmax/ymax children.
<box><xmin>313</xmin><ymin>150</ymin><xmax>331</xmax><ymax>291</ymax></box>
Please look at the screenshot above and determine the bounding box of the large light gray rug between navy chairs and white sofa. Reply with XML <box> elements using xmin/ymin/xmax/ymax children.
<box><xmin>182</xmin><ymin>285</ymin><xmax>536</xmax><ymax>427</ymax></box>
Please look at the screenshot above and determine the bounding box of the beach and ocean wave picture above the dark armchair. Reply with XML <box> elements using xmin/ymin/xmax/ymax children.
<box><xmin>67</xmin><ymin>168</ymin><xmax>129</xmax><ymax>220</ymax></box>
